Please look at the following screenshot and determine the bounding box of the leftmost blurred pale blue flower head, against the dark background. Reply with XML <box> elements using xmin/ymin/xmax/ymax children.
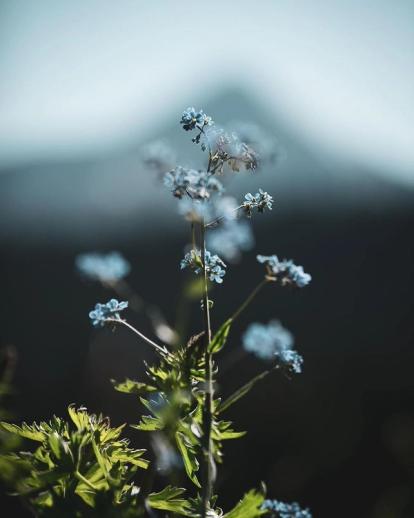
<box><xmin>75</xmin><ymin>252</ymin><xmax>131</xmax><ymax>282</ymax></box>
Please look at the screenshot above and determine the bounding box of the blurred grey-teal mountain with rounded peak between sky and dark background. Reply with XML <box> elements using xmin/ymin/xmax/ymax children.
<box><xmin>0</xmin><ymin>89</ymin><xmax>414</xmax><ymax>246</ymax></box>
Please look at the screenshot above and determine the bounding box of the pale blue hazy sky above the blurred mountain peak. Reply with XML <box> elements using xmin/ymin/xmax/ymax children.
<box><xmin>0</xmin><ymin>0</ymin><xmax>414</xmax><ymax>185</ymax></box>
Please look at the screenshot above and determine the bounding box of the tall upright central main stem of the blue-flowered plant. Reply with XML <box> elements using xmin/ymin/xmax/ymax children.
<box><xmin>201</xmin><ymin>220</ymin><xmax>214</xmax><ymax>518</ymax></box>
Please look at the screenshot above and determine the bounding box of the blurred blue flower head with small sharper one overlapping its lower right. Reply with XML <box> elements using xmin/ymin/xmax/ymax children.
<box><xmin>243</xmin><ymin>320</ymin><xmax>303</xmax><ymax>373</ymax></box>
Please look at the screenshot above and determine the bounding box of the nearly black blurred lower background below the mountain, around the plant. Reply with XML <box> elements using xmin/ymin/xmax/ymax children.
<box><xmin>0</xmin><ymin>181</ymin><xmax>414</xmax><ymax>518</ymax></box>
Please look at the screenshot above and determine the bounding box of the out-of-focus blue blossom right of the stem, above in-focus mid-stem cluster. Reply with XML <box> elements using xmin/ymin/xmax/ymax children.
<box><xmin>207</xmin><ymin>219</ymin><xmax>254</xmax><ymax>262</ymax></box>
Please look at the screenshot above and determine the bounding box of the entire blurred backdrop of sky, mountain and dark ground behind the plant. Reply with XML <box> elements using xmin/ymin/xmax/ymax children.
<box><xmin>0</xmin><ymin>0</ymin><xmax>414</xmax><ymax>518</ymax></box>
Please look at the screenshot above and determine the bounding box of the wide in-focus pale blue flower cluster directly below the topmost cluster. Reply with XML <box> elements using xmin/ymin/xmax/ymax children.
<box><xmin>164</xmin><ymin>166</ymin><xmax>223</xmax><ymax>200</ymax></box>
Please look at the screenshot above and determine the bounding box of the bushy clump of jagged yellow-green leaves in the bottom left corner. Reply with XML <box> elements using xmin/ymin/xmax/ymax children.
<box><xmin>0</xmin><ymin>406</ymin><xmax>148</xmax><ymax>516</ymax></box>
